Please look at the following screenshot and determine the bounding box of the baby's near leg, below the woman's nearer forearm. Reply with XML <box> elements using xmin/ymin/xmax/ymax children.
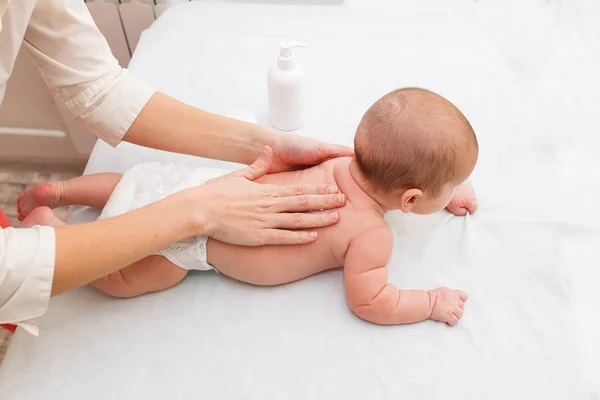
<box><xmin>92</xmin><ymin>256</ymin><xmax>188</xmax><ymax>298</ymax></box>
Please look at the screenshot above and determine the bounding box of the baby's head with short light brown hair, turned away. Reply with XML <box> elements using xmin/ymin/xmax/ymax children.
<box><xmin>354</xmin><ymin>88</ymin><xmax>479</xmax><ymax>214</ymax></box>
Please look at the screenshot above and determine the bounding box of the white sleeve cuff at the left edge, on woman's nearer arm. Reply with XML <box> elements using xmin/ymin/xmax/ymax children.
<box><xmin>0</xmin><ymin>226</ymin><xmax>56</xmax><ymax>335</ymax></box>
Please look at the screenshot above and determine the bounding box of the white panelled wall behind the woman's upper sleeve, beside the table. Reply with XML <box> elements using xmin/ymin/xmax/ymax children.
<box><xmin>0</xmin><ymin>0</ymin><xmax>168</xmax><ymax>163</ymax></box>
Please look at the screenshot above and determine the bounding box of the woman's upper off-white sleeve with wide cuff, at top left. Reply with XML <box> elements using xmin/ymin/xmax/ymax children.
<box><xmin>23</xmin><ymin>0</ymin><xmax>155</xmax><ymax>146</ymax></box>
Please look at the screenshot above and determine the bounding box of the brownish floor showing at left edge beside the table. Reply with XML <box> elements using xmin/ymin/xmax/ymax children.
<box><xmin>0</xmin><ymin>162</ymin><xmax>84</xmax><ymax>364</ymax></box>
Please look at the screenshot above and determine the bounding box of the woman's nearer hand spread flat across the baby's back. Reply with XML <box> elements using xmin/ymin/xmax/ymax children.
<box><xmin>188</xmin><ymin>147</ymin><xmax>346</xmax><ymax>246</ymax></box>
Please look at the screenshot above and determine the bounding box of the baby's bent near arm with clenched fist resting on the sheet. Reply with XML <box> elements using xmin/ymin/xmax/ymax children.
<box><xmin>344</xmin><ymin>226</ymin><xmax>467</xmax><ymax>326</ymax></box>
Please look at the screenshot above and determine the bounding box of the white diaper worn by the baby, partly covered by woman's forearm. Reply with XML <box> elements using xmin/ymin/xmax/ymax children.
<box><xmin>98</xmin><ymin>162</ymin><xmax>230</xmax><ymax>270</ymax></box>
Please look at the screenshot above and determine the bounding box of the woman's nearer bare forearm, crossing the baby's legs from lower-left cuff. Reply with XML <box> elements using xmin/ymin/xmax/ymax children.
<box><xmin>52</xmin><ymin>194</ymin><xmax>202</xmax><ymax>296</ymax></box>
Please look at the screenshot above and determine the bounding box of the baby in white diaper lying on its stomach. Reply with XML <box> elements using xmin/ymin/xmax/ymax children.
<box><xmin>18</xmin><ymin>88</ymin><xmax>478</xmax><ymax>326</ymax></box>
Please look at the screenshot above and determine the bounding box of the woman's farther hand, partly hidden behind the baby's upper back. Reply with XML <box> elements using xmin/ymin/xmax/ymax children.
<box><xmin>269</xmin><ymin>134</ymin><xmax>354</xmax><ymax>172</ymax></box>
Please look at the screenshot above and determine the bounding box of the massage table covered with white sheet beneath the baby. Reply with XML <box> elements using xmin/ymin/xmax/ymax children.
<box><xmin>0</xmin><ymin>0</ymin><xmax>600</xmax><ymax>400</ymax></box>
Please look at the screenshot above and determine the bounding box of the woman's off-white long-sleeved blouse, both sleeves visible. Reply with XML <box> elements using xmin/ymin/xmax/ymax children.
<box><xmin>0</xmin><ymin>0</ymin><xmax>155</xmax><ymax>334</ymax></box>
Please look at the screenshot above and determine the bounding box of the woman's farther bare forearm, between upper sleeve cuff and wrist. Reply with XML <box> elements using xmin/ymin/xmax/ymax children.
<box><xmin>123</xmin><ymin>92</ymin><xmax>274</xmax><ymax>164</ymax></box>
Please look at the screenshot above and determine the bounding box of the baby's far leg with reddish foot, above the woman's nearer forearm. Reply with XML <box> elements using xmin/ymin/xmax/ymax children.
<box><xmin>17</xmin><ymin>172</ymin><xmax>122</xmax><ymax>221</ymax></box>
